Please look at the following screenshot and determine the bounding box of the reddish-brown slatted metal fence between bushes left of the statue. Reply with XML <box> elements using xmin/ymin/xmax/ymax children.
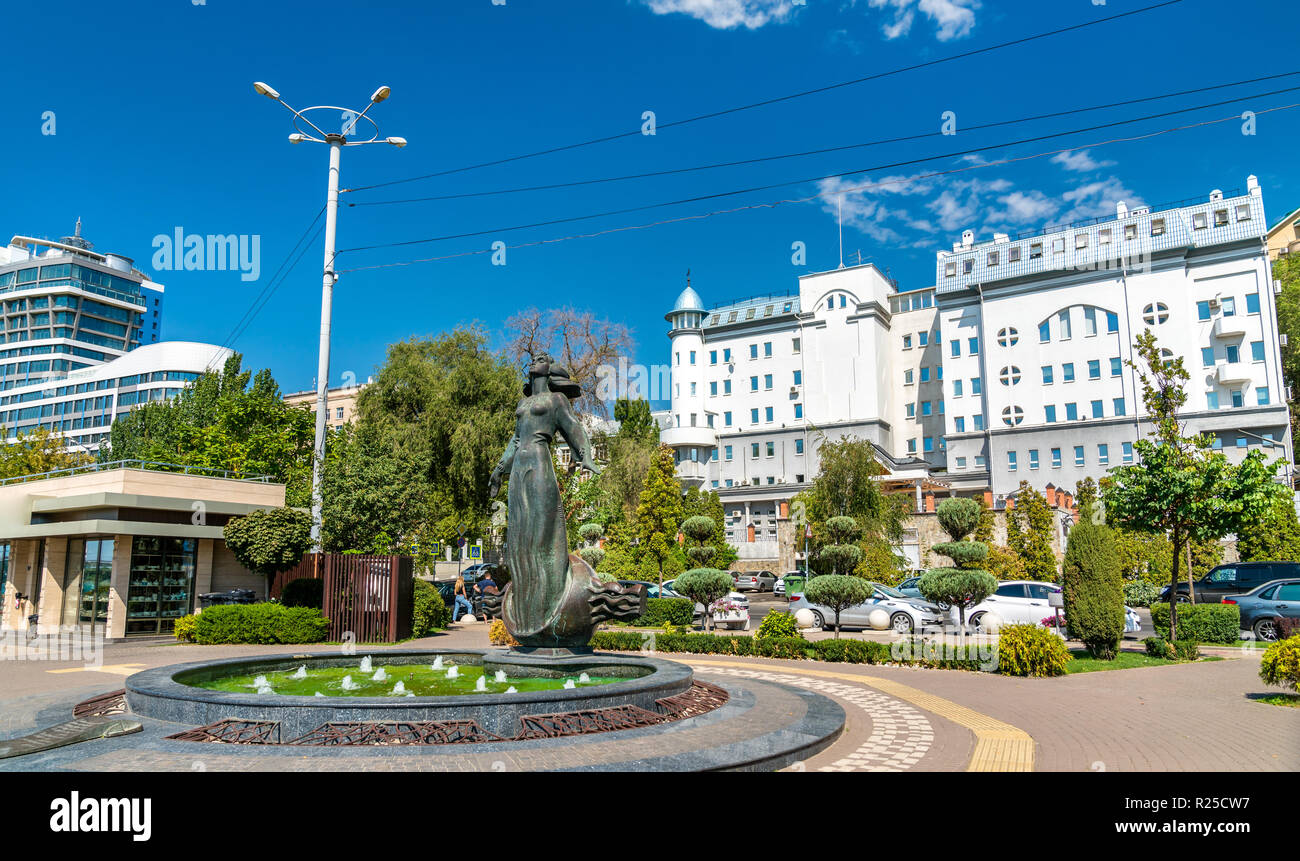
<box><xmin>270</xmin><ymin>553</ymin><xmax>415</xmax><ymax>642</ymax></box>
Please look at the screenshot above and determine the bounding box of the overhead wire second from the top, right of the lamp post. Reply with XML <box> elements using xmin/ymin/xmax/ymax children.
<box><xmin>347</xmin><ymin>70</ymin><xmax>1300</xmax><ymax>207</ymax></box>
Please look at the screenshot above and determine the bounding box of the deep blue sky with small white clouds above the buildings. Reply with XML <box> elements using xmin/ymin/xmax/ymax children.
<box><xmin>0</xmin><ymin>0</ymin><xmax>1300</xmax><ymax>390</ymax></box>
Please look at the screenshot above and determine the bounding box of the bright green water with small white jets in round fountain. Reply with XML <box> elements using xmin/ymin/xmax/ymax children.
<box><xmin>187</xmin><ymin>662</ymin><xmax>632</xmax><ymax>697</ymax></box>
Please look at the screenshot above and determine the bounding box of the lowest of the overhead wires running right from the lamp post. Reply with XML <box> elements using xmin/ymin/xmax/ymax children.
<box><xmin>339</xmin><ymin>103</ymin><xmax>1300</xmax><ymax>274</ymax></box>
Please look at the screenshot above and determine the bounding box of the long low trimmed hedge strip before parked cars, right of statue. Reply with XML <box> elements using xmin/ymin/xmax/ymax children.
<box><xmin>592</xmin><ymin>631</ymin><xmax>980</xmax><ymax>670</ymax></box>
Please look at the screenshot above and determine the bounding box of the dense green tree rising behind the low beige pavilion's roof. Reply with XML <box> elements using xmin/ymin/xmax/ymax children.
<box><xmin>99</xmin><ymin>354</ymin><xmax>316</xmax><ymax>506</ymax></box>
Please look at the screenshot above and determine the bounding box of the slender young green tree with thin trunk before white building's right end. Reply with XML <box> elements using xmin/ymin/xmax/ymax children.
<box><xmin>1102</xmin><ymin>329</ymin><xmax>1291</xmax><ymax>641</ymax></box>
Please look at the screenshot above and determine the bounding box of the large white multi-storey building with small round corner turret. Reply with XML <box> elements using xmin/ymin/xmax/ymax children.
<box><xmin>660</xmin><ymin>177</ymin><xmax>1292</xmax><ymax>558</ymax></box>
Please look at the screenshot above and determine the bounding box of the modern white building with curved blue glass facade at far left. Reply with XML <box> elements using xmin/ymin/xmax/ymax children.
<box><xmin>0</xmin><ymin>221</ymin><xmax>230</xmax><ymax>450</ymax></box>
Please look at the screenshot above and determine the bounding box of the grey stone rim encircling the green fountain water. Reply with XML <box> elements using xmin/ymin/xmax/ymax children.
<box><xmin>125</xmin><ymin>649</ymin><xmax>694</xmax><ymax>711</ymax></box>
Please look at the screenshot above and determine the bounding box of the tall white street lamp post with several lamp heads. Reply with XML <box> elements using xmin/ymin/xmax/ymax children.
<box><xmin>252</xmin><ymin>81</ymin><xmax>407</xmax><ymax>553</ymax></box>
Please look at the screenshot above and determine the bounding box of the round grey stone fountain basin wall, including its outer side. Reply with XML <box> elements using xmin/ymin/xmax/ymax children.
<box><xmin>126</xmin><ymin>649</ymin><xmax>693</xmax><ymax>740</ymax></box>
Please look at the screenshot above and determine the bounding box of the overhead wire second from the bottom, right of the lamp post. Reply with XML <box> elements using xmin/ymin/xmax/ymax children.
<box><xmin>339</xmin><ymin>87</ymin><xmax>1300</xmax><ymax>255</ymax></box>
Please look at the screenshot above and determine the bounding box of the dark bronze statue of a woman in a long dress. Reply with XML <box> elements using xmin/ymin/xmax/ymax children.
<box><xmin>488</xmin><ymin>354</ymin><xmax>645</xmax><ymax>650</ymax></box>
